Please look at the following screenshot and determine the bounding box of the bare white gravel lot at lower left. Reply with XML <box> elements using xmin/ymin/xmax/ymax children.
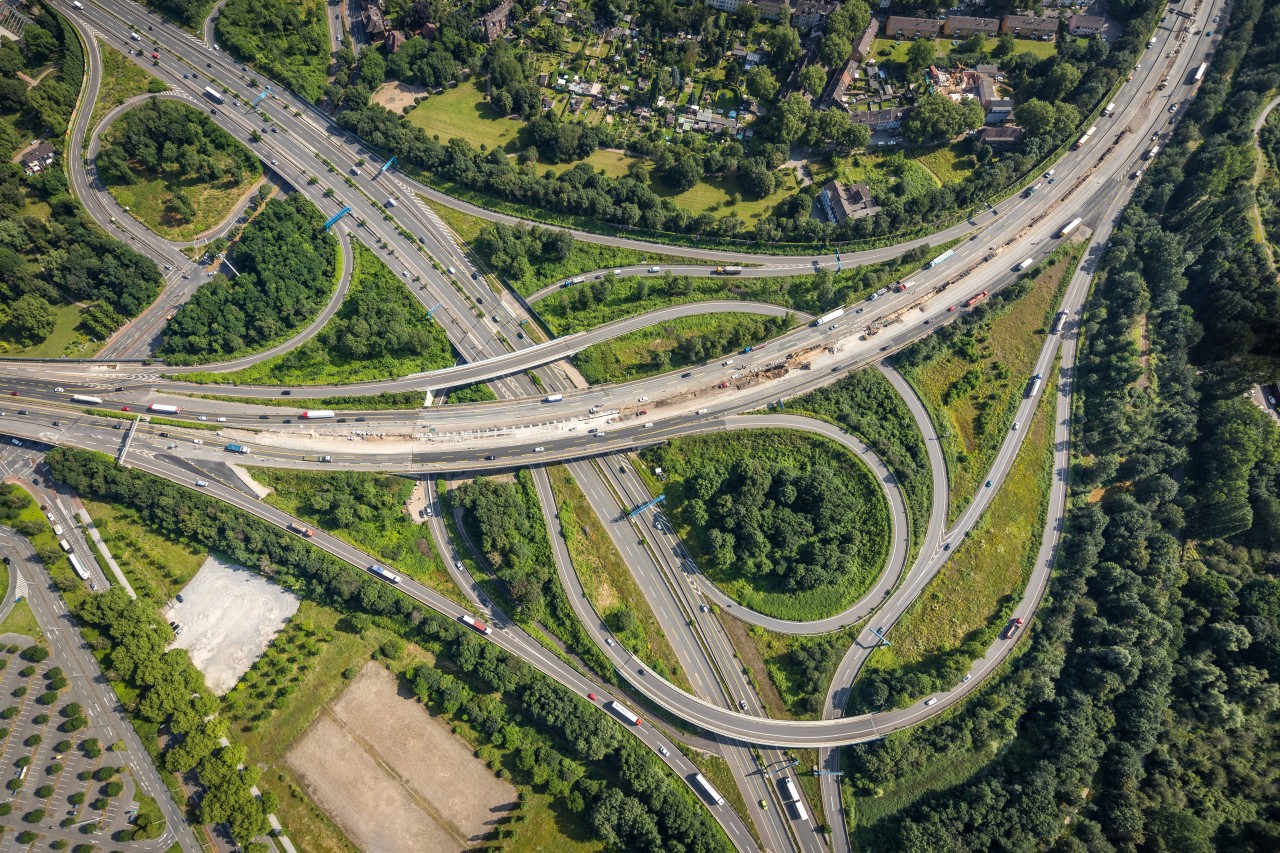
<box><xmin>166</xmin><ymin>557</ymin><xmax>298</xmax><ymax>695</ymax></box>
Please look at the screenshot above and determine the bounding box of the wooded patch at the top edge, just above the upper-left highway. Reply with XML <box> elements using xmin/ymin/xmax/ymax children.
<box><xmin>214</xmin><ymin>0</ymin><xmax>330</xmax><ymax>102</ymax></box>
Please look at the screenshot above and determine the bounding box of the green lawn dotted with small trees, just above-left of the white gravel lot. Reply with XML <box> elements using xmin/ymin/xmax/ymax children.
<box><xmin>84</xmin><ymin>501</ymin><xmax>207</xmax><ymax>605</ymax></box>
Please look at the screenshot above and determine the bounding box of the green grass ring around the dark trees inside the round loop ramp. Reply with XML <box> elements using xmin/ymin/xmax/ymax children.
<box><xmin>640</xmin><ymin>429</ymin><xmax>890</xmax><ymax>620</ymax></box>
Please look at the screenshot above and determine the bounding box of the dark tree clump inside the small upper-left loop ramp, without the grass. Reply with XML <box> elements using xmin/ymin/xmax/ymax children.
<box><xmin>97</xmin><ymin>97</ymin><xmax>262</xmax><ymax>222</ymax></box>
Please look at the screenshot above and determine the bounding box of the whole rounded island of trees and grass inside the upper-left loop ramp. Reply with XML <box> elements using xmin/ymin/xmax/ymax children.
<box><xmin>96</xmin><ymin>97</ymin><xmax>262</xmax><ymax>240</ymax></box>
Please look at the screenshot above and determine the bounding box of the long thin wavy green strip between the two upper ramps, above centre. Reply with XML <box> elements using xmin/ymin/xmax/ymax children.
<box><xmin>534</xmin><ymin>242</ymin><xmax>955</xmax><ymax>336</ymax></box>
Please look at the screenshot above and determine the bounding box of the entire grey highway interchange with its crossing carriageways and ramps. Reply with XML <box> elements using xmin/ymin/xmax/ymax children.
<box><xmin>0</xmin><ymin>0</ymin><xmax>1221</xmax><ymax>849</ymax></box>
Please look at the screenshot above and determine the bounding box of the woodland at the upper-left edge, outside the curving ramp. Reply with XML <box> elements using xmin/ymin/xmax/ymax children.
<box><xmin>0</xmin><ymin>6</ymin><xmax>160</xmax><ymax>345</ymax></box>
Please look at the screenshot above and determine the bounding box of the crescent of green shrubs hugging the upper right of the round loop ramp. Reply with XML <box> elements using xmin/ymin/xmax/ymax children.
<box><xmin>786</xmin><ymin>368</ymin><xmax>933</xmax><ymax>546</ymax></box>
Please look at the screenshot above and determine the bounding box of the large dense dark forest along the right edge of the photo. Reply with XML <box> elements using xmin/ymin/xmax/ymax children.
<box><xmin>847</xmin><ymin>0</ymin><xmax>1280</xmax><ymax>852</ymax></box>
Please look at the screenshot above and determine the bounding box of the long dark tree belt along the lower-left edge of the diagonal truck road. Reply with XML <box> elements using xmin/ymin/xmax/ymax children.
<box><xmin>47</xmin><ymin>448</ymin><xmax>731</xmax><ymax>853</ymax></box>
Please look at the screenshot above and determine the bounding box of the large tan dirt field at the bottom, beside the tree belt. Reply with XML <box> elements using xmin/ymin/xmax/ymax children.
<box><xmin>287</xmin><ymin>663</ymin><xmax>516</xmax><ymax>853</ymax></box>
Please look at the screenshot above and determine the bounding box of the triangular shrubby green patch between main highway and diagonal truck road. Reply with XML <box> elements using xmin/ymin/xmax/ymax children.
<box><xmin>250</xmin><ymin>467</ymin><xmax>466</xmax><ymax>605</ymax></box>
